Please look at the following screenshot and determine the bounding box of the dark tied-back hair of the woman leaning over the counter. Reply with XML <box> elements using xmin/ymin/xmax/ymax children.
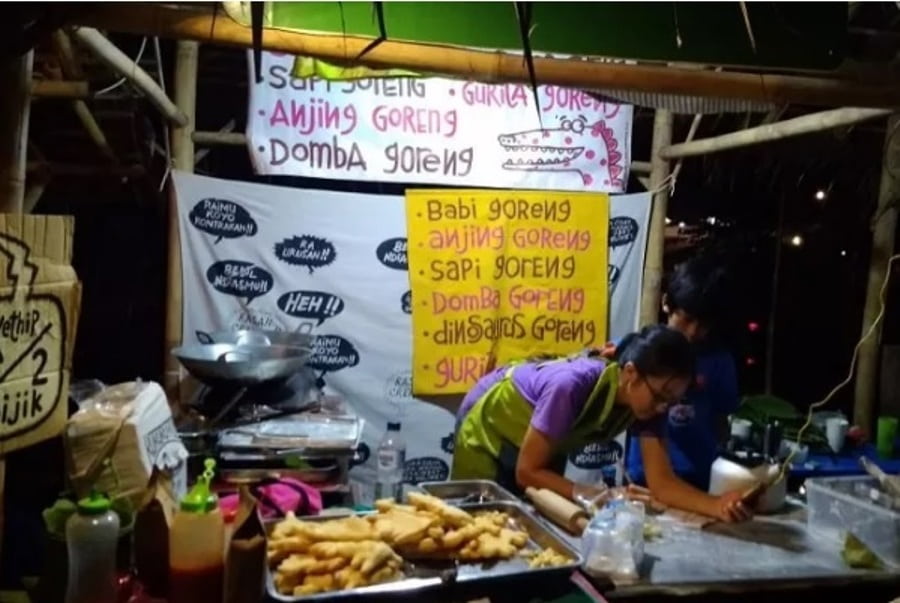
<box><xmin>615</xmin><ymin>325</ymin><xmax>695</xmax><ymax>379</ymax></box>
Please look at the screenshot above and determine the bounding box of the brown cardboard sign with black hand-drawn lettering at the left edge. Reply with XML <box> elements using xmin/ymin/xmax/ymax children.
<box><xmin>0</xmin><ymin>214</ymin><xmax>81</xmax><ymax>456</ymax></box>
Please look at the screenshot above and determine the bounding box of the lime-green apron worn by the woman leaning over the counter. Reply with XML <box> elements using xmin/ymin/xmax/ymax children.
<box><xmin>450</xmin><ymin>359</ymin><xmax>634</xmax><ymax>491</ymax></box>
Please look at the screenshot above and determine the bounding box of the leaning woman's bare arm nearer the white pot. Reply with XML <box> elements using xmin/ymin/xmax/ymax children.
<box><xmin>640</xmin><ymin>435</ymin><xmax>750</xmax><ymax>521</ymax></box>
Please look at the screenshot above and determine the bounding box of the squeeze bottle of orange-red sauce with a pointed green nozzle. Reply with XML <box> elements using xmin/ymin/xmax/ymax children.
<box><xmin>168</xmin><ymin>459</ymin><xmax>225</xmax><ymax>603</ymax></box>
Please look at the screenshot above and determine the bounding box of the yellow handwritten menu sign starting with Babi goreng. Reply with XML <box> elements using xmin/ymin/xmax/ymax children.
<box><xmin>406</xmin><ymin>190</ymin><xmax>609</xmax><ymax>395</ymax></box>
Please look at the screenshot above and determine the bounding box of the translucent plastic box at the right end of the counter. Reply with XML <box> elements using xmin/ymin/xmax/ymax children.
<box><xmin>806</xmin><ymin>476</ymin><xmax>900</xmax><ymax>567</ymax></box>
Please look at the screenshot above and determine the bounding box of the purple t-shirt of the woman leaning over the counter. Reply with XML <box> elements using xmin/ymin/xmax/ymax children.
<box><xmin>457</xmin><ymin>357</ymin><xmax>664</xmax><ymax>440</ymax></box>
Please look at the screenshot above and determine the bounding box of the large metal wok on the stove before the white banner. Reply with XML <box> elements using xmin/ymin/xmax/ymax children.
<box><xmin>172</xmin><ymin>343</ymin><xmax>310</xmax><ymax>386</ymax></box>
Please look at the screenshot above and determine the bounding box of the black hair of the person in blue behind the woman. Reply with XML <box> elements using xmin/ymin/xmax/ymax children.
<box><xmin>666</xmin><ymin>256</ymin><xmax>733</xmax><ymax>331</ymax></box>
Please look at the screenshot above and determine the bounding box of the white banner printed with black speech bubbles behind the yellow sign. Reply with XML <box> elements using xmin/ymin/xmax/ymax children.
<box><xmin>173</xmin><ymin>172</ymin><xmax>650</xmax><ymax>496</ymax></box>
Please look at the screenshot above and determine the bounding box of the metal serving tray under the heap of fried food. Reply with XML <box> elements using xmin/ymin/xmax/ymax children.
<box><xmin>266</xmin><ymin>501</ymin><xmax>583</xmax><ymax>603</ymax></box>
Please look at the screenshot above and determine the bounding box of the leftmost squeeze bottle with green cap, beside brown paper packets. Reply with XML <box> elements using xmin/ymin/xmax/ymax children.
<box><xmin>66</xmin><ymin>492</ymin><xmax>119</xmax><ymax>603</ymax></box>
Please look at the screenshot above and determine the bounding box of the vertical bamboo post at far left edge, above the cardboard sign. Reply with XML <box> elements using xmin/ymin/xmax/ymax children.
<box><xmin>0</xmin><ymin>51</ymin><xmax>34</xmax><ymax>568</ymax></box>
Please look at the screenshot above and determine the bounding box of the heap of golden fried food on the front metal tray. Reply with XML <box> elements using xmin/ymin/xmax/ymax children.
<box><xmin>267</xmin><ymin>493</ymin><xmax>536</xmax><ymax>597</ymax></box>
